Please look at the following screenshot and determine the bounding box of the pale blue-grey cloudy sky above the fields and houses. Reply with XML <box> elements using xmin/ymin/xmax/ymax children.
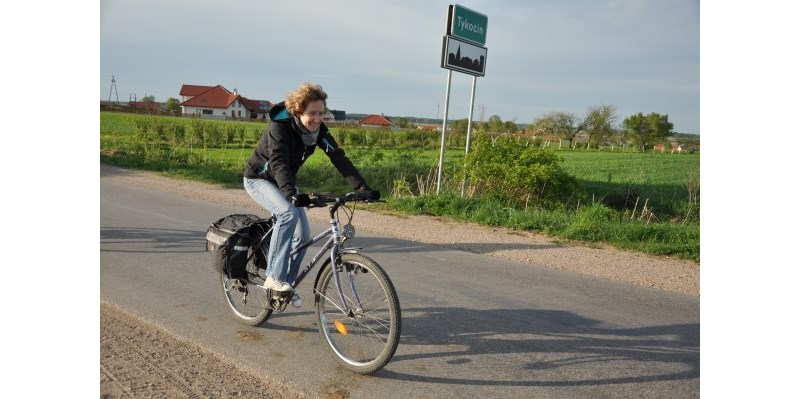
<box><xmin>99</xmin><ymin>0</ymin><xmax>700</xmax><ymax>133</ymax></box>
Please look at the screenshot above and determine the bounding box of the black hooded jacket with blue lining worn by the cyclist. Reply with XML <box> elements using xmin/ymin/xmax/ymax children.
<box><xmin>244</xmin><ymin>102</ymin><xmax>366</xmax><ymax>197</ymax></box>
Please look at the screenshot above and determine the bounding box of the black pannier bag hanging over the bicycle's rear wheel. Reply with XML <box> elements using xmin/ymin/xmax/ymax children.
<box><xmin>206</xmin><ymin>214</ymin><xmax>263</xmax><ymax>278</ymax></box>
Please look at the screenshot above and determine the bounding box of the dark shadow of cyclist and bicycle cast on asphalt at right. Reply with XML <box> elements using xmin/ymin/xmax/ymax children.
<box><xmin>376</xmin><ymin>308</ymin><xmax>700</xmax><ymax>386</ymax></box>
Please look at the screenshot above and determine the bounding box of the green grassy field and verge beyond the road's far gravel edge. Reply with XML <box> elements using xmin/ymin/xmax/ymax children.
<box><xmin>100</xmin><ymin>112</ymin><xmax>700</xmax><ymax>261</ymax></box>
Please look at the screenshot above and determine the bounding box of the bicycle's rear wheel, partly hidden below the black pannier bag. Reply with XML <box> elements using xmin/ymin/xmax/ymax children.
<box><xmin>220</xmin><ymin>249</ymin><xmax>272</xmax><ymax>326</ymax></box>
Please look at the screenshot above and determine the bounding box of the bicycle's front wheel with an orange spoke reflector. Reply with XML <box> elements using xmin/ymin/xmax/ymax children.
<box><xmin>314</xmin><ymin>254</ymin><xmax>401</xmax><ymax>374</ymax></box>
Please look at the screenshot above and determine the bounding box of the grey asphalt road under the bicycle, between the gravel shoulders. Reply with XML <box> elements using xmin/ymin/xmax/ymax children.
<box><xmin>100</xmin><ymin>179</ymin><xmax>700</xmax><ymax>398</ymax></box>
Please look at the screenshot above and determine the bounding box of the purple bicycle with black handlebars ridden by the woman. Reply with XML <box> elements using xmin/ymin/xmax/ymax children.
<box><xmin>220</xmin><ymin>193</ymin><xmax>401</xmax><ymax>374</ymax></box>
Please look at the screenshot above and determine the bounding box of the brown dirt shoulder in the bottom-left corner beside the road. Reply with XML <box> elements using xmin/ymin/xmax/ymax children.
<box><xmin>100</xmin><ymin>303</ymin><xmax>306</xmax><ymax>399</ymax></box>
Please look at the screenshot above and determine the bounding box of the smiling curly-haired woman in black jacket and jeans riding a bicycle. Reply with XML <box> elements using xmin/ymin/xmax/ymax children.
<box><xmin>244</xmin><ymin>83</ymin><xmax>380</xmax><ymax>307</ymax></box>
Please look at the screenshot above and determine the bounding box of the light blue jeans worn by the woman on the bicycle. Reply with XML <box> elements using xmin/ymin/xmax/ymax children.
<box><xmin>244</xmin><ymin>177</ymin><xmax>311</xmax><ymax>285</ymax></box>
